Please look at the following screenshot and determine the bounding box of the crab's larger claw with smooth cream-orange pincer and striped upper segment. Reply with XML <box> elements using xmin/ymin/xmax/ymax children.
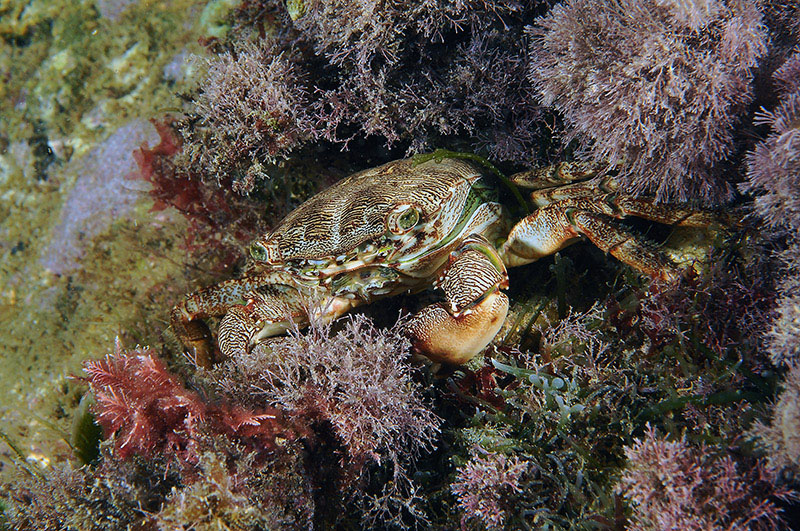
<box><xmin>406</xmin><ymin>236</ymin><xmax>508</xmax><ymax>364</ymax></box>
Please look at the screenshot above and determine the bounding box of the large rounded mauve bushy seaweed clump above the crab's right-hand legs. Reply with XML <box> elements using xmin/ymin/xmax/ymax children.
<box><xmin>531</xmin><ymin>0</ymin><xmax>768</xmax><ymax>203</ymax></box>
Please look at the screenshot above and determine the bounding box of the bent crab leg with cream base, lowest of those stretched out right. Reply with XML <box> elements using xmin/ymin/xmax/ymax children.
<box><xmin>500</xmin><ymin>206</ymin><xmax>678</xmax><ymax>280</ymax></box>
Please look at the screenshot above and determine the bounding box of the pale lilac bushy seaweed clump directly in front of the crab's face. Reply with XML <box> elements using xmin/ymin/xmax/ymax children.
<box><xmin>210</xmin><ymin>315</ymin><xmax>440</xmax><ymax>524</ymax></box>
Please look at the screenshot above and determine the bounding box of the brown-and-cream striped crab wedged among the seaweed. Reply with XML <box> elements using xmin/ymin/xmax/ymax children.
<box><xmin>171</xmin><ymin>157</ymin><xmax>715</xmax><ymax>367</ymax></box>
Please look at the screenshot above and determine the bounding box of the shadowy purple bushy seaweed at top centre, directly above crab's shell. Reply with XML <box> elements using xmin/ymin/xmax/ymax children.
<box><xmin>295</xmin><ymin>0</ymin><xmax>536</xmax><ymax>160</ymax></box>
